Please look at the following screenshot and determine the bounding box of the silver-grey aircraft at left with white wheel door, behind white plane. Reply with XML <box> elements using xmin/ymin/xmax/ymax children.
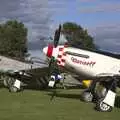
<box><xmin>0</xmin><ymin>56</ymin><xmax>48</xmax><ymax>92</ymax></box>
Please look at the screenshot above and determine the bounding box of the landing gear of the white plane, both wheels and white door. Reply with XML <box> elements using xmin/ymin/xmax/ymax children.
<box><xmin>82</xmin><ymin>77</ymin><xmax>118</xmax><ymax>112</ymax></box>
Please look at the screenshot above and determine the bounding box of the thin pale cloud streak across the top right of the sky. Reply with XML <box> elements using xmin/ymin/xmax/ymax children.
<box><xmin>79</xmin><ymin>2</ymin><xmax>120</xmax><ymax>13</ymax></box>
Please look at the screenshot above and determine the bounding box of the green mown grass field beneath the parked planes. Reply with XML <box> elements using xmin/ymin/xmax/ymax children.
<box><xmin>0</xmin><ymin>89</ymin><xmax>120</xmax><ymax>120</ymax></box>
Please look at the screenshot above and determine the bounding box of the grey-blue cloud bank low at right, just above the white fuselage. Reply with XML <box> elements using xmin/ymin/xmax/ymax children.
<box><xmin>89</xmin><ymin>23</ymin><xmax>120</xmax><ymax>53</ymax></box>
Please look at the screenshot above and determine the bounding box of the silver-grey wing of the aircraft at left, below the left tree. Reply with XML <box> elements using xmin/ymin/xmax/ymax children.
<box><xmin>0</xmin><ymin>56</ymin><xmax>48</xmax><ymax>79</ymax></box>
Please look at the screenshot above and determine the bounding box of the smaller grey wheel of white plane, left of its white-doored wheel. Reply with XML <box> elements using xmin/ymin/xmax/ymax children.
<box><xmin>81</xmin><ymin>92</ymin><xmax>93</xmax><ymax>102</ymax></box>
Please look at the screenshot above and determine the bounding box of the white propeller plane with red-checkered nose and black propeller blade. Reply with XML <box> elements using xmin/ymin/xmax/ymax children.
<box><xmin>43</xmin><ymin>25</ymin><xmax>120</xmax><ymax>112</ymax></box>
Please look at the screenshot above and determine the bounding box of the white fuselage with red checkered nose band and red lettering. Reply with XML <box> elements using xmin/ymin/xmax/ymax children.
<box><xmin>43</xmin><ymin>46</ymin><xmax>120</xmax><ymax>77</ymax></box>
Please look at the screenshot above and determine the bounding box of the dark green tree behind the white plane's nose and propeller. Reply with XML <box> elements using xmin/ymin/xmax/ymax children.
<box><xmin>62</xmin><ymin>22</ymin><xmax>96</xmax><ymax>50</ymax></box>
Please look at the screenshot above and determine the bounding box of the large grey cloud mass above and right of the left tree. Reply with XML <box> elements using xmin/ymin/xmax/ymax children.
<box><xmin>0</xmin><ymin>0</ymin><xmax>52</xmax><ymax>57</ymax></box>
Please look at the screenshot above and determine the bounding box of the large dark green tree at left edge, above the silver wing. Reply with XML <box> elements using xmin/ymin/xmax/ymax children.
<box><xmin>0</xmin><ymin>20</ymin><xmax>27</xmax><ymax>60</ymax></box>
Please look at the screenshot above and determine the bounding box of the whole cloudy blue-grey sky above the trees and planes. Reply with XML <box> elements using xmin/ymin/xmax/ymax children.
<box><xmin>0</xmin><ymin>0</ymin><xmax>120</xmax><ymax>56</ymax></box>
